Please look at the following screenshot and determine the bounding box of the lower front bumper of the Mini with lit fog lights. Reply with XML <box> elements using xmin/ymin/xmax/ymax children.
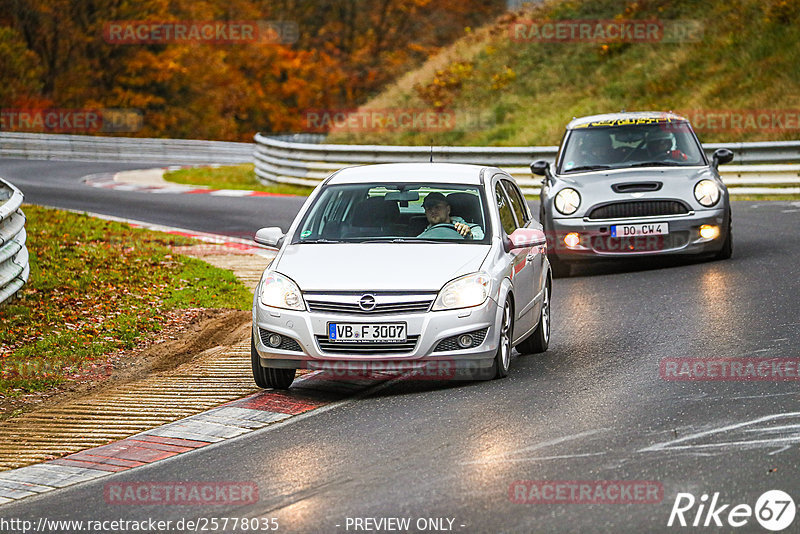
<box><xmin>548</xmin><ymin>206</ymin><xmax>729</xmax><ymax>261</ymax></box>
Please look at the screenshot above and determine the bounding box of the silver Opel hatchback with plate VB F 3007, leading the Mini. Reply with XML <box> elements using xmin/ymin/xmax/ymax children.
<box><xmin>251</xmin><ymin>163</ymin><xmax>551</xmax><ymax>388</ymax></box>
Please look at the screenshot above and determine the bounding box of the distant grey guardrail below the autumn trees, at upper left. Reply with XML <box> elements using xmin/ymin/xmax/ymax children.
<box><xmin>0</xmin><ymin>132</ymin><xmax>253</xmax><ymax>165</ymax></box>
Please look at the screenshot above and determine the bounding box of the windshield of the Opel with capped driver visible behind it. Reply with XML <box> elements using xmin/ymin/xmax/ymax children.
<box><xmin>292</xmin><ymin>183</ymin><xmax>490</xmax><ymax>243</ymax></box>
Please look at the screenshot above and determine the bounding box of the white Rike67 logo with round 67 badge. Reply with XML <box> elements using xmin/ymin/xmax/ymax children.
<box><xmin>667</xmin><ymin>490</ymin><xmax>797</xmax><ymax>532</ymax></box>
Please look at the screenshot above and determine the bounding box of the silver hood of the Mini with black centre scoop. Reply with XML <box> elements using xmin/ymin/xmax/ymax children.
<box><xmin>554</xmin><ymin>167</ymin><xmax>714</xmax><ymax>217</ymax></box>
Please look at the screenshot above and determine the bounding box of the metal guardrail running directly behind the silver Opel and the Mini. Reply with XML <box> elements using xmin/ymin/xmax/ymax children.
<box><xmin>253</xmin><ymin>134</ymin><xmax>800</xmax><ymax>194</ymax></box>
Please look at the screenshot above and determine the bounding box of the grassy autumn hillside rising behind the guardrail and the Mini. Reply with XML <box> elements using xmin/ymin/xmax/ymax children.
<box><xmin>331</xmin><ymin>0</ymin><xmax>800</xmax><ymax>146</ymax></box>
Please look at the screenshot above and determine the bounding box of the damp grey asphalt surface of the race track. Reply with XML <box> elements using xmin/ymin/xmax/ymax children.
<box><xmin>0</xmin><ymin>161</ymin><xmax>800</xmax><ymax>532</ymax></box>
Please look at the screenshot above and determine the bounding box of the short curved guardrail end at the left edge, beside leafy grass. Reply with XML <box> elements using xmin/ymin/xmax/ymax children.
<box><xmin>0</xmin><ymin>178</ymin><xmax>30</xmax><ymax>304</ymax></box>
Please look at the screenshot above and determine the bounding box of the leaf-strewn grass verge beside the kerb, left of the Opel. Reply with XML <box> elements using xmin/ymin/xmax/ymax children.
<box><xmin>0</xmin><ymin>205</ymin><xmax>252</xmax><ymax>397</ymax></box>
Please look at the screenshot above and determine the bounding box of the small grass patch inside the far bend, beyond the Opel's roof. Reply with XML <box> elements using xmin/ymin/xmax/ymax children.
<box><xmin>164</xmin><ymin>164</ymin><xmax>312</xmax><ymax>196</ymax></box>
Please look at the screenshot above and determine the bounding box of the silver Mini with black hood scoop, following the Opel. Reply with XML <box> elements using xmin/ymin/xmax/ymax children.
<box><xmin>531</xmin><ymin>112</ymin><xmax>733</xmax><ymax>276</ymax></box>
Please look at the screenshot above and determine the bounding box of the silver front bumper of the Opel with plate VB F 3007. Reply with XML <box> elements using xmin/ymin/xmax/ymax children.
<box><xmin>253</xmin><ymin>298</ymin><xmax>502</xmax><ymax>369</ymax></box>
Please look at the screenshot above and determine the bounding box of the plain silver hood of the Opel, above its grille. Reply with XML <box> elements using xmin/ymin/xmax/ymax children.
<box><xmin>271</xmin><ymin>243</ymin><xmax>490</xmax><ymax>292</ymax></box>
